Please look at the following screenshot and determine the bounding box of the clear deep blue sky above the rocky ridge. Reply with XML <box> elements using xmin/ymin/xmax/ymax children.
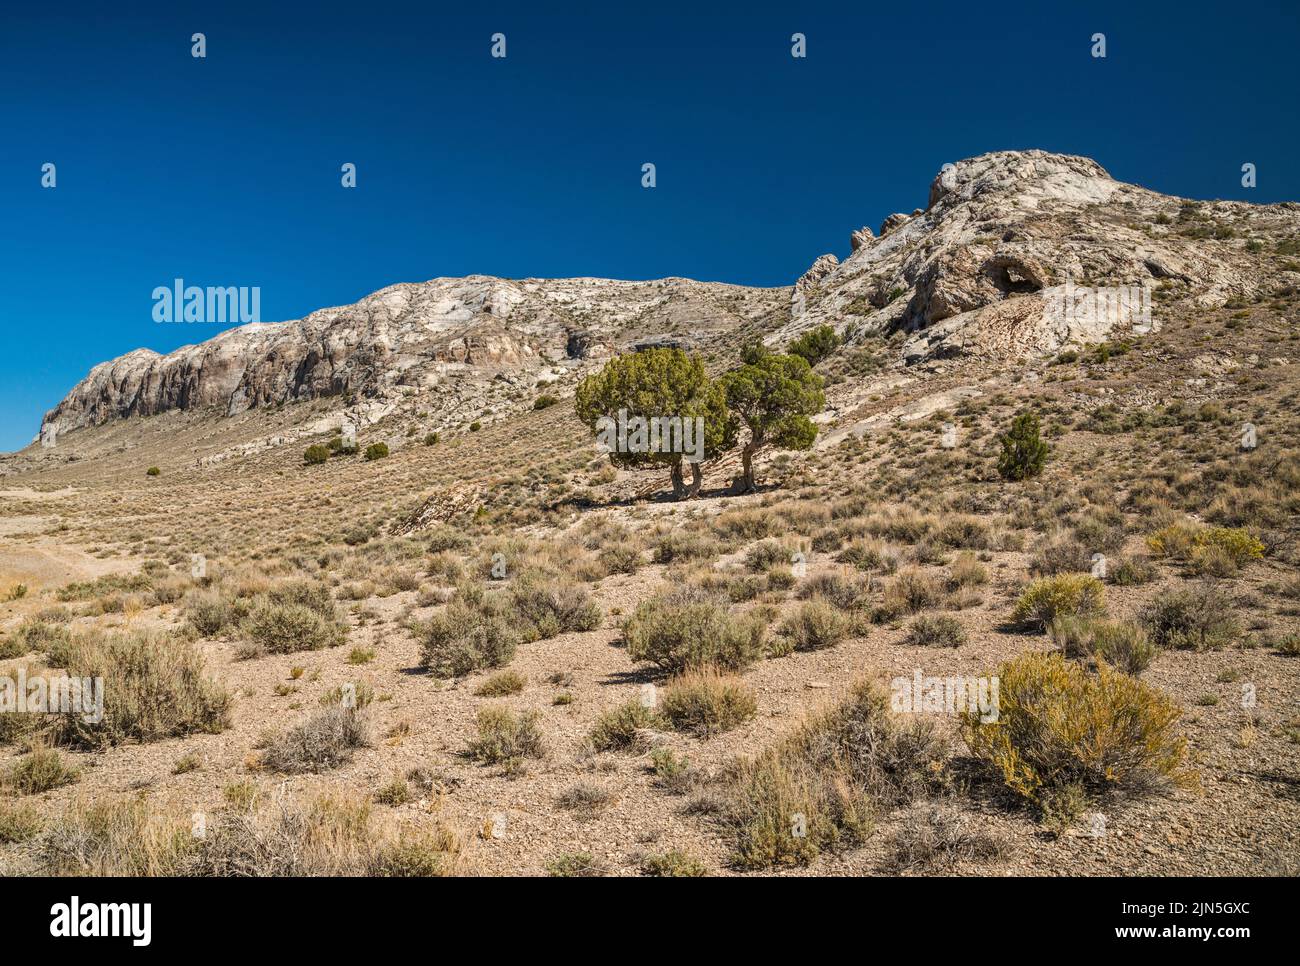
<box><xmin>0</xmin><ymin>0</ymin><xmax>1300</xmax><ymax>450</ymax></box>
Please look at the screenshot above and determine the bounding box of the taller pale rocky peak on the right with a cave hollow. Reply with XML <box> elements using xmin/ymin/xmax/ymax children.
<box><xmin>772</xmin><ymin>151</ymin><xmax>1300</xmax><ymax>361</ymax></box>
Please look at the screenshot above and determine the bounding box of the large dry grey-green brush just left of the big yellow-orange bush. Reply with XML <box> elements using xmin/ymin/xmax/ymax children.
<box><xmin>719</xmin><ymin>683</ymin><xmax>946</xmax><ymax>868</ymax></box>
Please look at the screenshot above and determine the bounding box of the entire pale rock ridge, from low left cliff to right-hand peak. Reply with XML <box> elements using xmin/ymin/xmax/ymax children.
<box><xmin>42</xmin><ymin>151</ymin><xmax>1300</xmax><ymax>437</ymax></box>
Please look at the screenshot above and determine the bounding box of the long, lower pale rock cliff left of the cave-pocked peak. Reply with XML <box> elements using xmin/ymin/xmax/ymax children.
<box><xmin>42</xmin><ymin>276</ymin><xmax>787</xmax><ymax>436</ymax></box>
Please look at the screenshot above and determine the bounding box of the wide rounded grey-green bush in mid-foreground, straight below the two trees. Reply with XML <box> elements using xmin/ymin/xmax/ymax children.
<box><xmin>623</xmin><ymin>586</ymin><xmax>766</xmax><ymax>671</ymax></box>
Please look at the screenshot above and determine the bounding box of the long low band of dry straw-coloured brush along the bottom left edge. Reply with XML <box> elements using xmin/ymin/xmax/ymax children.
<box><xmin>30</xmin><ymin>794</ymin><xmax>463</xmax><ymax>878</ymax></box>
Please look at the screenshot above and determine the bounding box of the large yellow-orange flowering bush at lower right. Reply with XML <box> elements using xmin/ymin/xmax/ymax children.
<box><xmin>965</xmin><ymin>653</ymin><xmax>1193</xmax><ymax>810</ymax></box>
